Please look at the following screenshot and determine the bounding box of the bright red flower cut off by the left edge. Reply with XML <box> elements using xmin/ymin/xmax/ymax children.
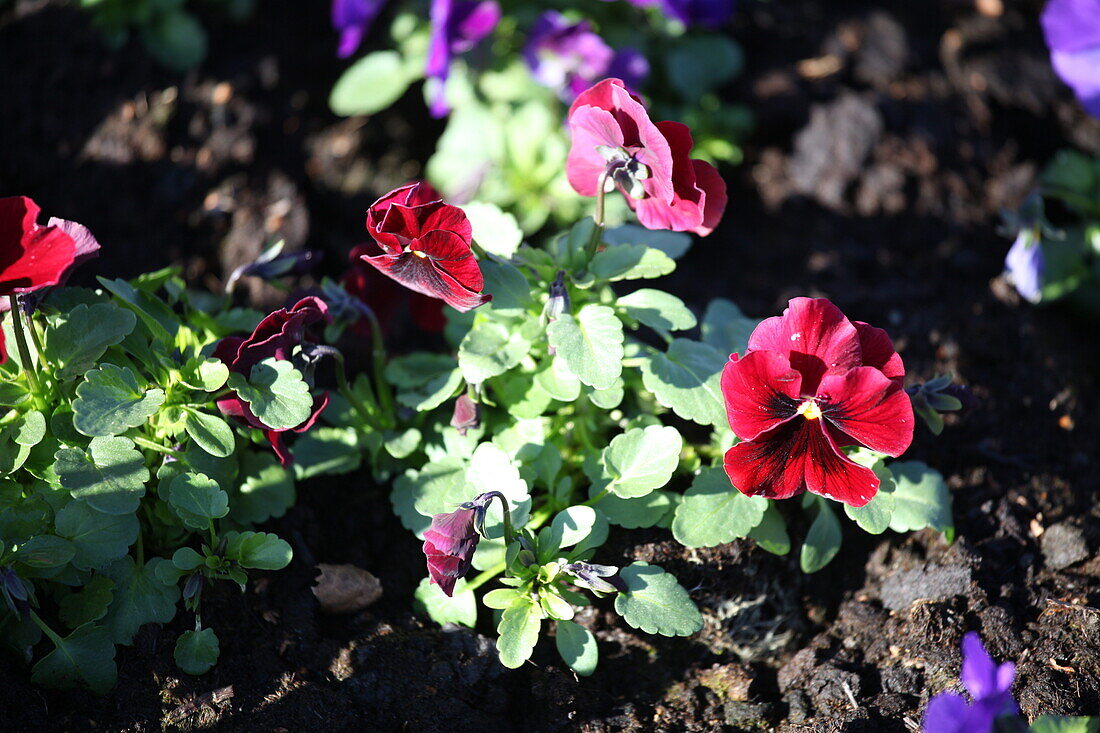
<box><xmin>0</xmin><ymin>196</ymin><xmax>79</xmax><ymax>296</ymax></box>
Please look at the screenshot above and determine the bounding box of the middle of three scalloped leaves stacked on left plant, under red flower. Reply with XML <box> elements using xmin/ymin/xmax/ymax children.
<box><xmin>73</xmin><ymin>364</ymin><xmax>164</xmax><ymax>437</ymax></box>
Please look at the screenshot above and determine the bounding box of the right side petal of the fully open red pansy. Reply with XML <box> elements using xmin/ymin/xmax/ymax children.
<box><xmin>817</xmin><ymin>367</ymin><xmax>913</xmax><ymax>456</ymax></box>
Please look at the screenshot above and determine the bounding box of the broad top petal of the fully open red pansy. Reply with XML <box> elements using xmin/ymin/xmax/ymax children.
<box><xmin>748</xmin><ymin>298</ymin><xmax>862</xmax><ymax>394</ymax></box>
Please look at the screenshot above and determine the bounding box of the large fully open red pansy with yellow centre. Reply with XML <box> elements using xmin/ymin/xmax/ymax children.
<box><xmin>722</xmin><ymin>298</ymin><xmax>913</xmax><ymax>506</ymax></box>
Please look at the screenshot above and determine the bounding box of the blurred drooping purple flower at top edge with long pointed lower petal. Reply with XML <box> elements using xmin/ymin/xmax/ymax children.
<box><xmin>424</xmin><ymin>0</ymin><xmax>501</xmax><ymax>118</ymax></box>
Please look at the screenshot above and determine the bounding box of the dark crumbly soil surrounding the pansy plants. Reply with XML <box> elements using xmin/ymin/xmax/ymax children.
<box><xmin>0</xmin><ymin>0</ymin><xmax>1100</xmax><ymax>733</ymax></box>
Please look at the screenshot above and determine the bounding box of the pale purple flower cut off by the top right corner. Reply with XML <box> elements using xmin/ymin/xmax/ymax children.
<box><xmin>1041</xmin><ymin>0</ymin><xmax>1100</xmax><ymax>118</ymax></box>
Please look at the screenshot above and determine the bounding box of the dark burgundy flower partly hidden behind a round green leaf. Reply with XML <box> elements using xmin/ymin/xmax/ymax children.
<box><xmin>213</xmin><ymin>297</ymin><xmax>332</xmax><ymax>467</ymax></box>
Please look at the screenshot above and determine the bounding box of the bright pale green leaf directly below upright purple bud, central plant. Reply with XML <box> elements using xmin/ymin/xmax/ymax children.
<box><xmin>547</xmin><ymin>305</ymin><xmax>624</xmax><ymax>390</ymax></box>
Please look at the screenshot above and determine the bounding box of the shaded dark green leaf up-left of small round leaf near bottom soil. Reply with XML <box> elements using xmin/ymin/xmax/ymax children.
<box><xmin>103</xmin><ymin>556</ymin><xmax>179</xmax><ymax>644</ymax></box>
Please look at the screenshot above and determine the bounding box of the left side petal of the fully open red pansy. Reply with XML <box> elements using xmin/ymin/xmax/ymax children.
<box><xmin>722</xmin><ymin>351</ymin><xmax>802</xmax><ymax>440</ymax></box>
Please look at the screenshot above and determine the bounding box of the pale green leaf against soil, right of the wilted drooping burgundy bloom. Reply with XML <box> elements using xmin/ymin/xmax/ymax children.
<box><xmin>615</xmin><ymin>561</ymin><xmax>703</xmax><ymax>636</ymax></box>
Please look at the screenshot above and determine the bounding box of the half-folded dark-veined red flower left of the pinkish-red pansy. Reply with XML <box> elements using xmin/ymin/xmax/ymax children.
<box><xmin>360</xmin><ymin>183</ymin><xmax>492</xmax><ymax>311</ymax></box>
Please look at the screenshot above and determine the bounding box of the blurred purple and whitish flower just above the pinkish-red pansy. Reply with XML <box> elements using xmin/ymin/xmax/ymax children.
<box><xmin>524</xmin><ymin>10</ymin><xmax>649</xmax><ymax>102</ymax></box>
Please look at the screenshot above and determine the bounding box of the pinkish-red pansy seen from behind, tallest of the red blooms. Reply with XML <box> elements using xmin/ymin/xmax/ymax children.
<box><xmin>565</xmin><ymin>79</ymin><xmax>726</xmax><ymax>237</ymax></box>
